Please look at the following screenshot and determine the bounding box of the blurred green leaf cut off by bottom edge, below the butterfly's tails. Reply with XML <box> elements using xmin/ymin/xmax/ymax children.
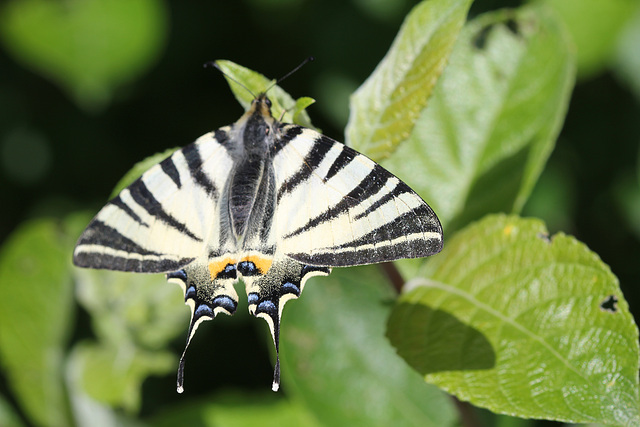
<box><xmin>150</xmin><ymin>391</ymin><xmax>319</xmax><ymax>427</ymax></box>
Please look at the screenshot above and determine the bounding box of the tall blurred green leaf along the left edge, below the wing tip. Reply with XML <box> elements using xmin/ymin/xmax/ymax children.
<box><xmin>0</xmin><ymin>219</ymin><xmax>73</xmax><ymax>426</ymax></box>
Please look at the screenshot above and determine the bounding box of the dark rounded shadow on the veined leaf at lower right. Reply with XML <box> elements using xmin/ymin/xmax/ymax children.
<box><xmin>387</xmin><ymin>303</ymin><xmax>496</xmax><ymax>375</ymax></box>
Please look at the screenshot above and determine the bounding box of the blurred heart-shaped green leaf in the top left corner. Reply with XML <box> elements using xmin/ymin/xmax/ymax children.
<box><xmin>0</xmin><ymin>0</ymin><xmax>167</xmax><ymax>109</ymax></box>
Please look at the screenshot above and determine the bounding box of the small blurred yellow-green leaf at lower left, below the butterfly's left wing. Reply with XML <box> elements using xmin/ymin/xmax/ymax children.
<box><xmin>69</xmin><ymin>341</ymin><xmax>176</xmax><ymax>412</ymax></box>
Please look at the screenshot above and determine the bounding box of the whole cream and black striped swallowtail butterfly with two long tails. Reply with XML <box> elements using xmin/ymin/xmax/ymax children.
<box><xmin>73</xmin><ymin>65</ymin><xmax>442</xmax><ymax>393</ymax></box>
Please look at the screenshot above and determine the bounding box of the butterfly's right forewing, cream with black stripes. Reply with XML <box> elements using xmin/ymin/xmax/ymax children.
<box><xmin>273</xmin><ymin>125</ymin><xmax>442</xmax><ymax>267</ymax></box>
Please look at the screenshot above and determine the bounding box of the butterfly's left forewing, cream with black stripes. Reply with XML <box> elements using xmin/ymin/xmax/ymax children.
<box><xmin>73</xmin><ymin>128</ymin><xmax>233</xmax><ymax>273</ymax></box>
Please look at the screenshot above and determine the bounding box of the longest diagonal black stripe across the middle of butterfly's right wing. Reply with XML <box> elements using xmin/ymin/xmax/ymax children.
<box><xmin>284</xmin><ymin>164</ymin><xmax>393</xmax><ymax>239</ymax></box>
